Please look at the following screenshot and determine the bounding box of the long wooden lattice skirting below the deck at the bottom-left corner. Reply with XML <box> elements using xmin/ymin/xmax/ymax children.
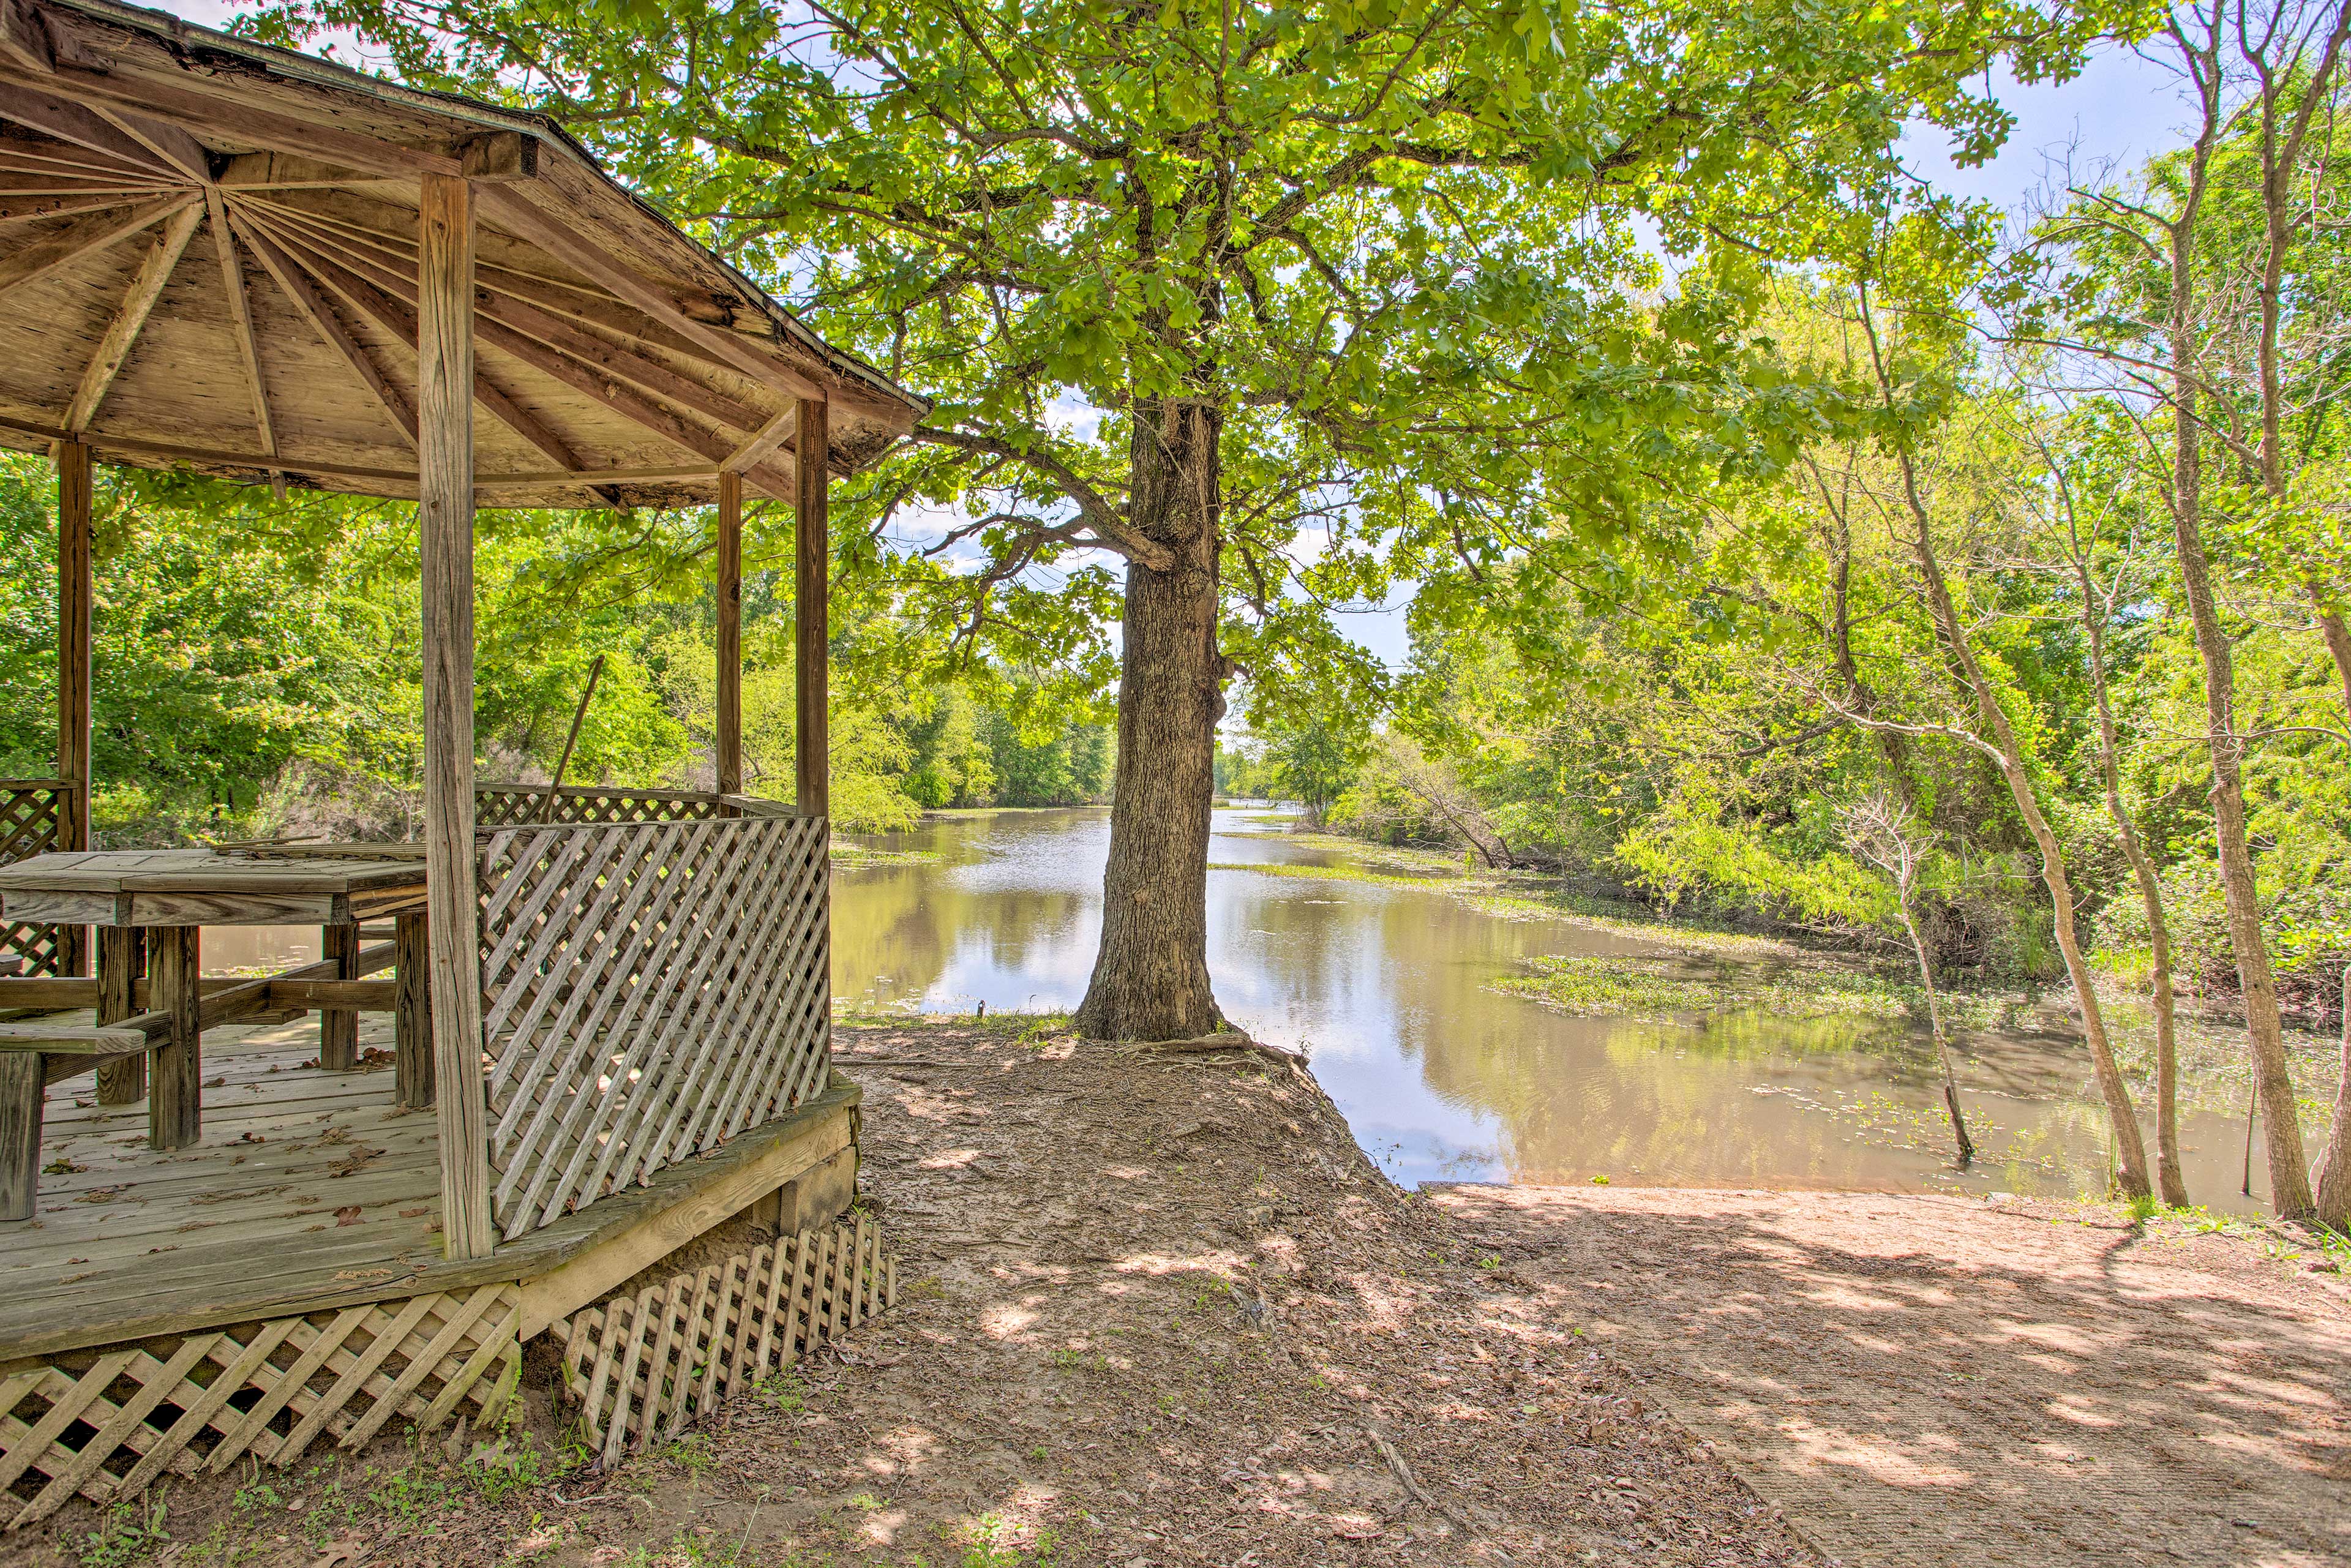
<box><xmin>0</xmin><ymin>1283</ymin><xmax>522</xmax><ymax>1528</ymax></box>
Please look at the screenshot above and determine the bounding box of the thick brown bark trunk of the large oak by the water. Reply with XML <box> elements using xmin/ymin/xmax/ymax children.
<box><xmin>1077</xmin><ymin>400</ymin><xmax>1229</xmax><ymax>1039</ymax></box>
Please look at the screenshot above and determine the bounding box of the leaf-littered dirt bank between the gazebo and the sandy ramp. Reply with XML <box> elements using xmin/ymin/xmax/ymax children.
<box><xmin>13</xmin><ymin>1022</ymin><xmax>1817</xmax><ymax>1568</ymax></box>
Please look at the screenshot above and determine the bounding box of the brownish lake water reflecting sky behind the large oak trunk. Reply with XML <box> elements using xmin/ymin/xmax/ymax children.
<box><xmin>832</xmin><ymin>809</ymin><xmax>2323</xmax><ymax>1210</ymax></box>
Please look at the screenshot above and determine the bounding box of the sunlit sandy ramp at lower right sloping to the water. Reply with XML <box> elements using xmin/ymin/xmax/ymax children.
<box><xmin>1436</xmin><ymin>1187</ymin><xmax>2351</xmax><ymax>1566</ymax></box>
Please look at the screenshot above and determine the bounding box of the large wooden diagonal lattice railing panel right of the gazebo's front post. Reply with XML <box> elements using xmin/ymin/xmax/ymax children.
<box><xmin>479</xmin><ymin>816</ymin><xmax>832</xmax><ymax>1237</ymax></box>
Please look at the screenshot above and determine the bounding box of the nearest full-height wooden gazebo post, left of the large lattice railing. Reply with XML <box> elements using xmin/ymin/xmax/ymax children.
<box><xmin>416</xmin><ymin>174</ymin><xmax>493</xmax><ymax>1258</ymax></box>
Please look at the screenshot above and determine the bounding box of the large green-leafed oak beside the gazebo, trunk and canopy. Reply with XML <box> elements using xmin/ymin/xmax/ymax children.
<box><xmin>263</xmin><ymin>0</ymin><xmax>2116</xmax><ymax>1039</ymax></box>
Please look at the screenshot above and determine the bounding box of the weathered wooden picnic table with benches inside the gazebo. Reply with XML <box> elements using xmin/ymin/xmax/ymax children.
<box><xmin>0</xmin><ymin>844</ymin><xmax>433</xmax><ymax>1218</ymax></box>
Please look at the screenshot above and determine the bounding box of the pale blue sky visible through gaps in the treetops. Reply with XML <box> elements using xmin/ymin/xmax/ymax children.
<box><xmin>162</xmin><ymin>0</ymin><xmax>2186</xmax><ymax>667</ymax></box>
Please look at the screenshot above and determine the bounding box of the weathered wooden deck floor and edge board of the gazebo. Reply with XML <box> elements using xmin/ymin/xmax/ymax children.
<box><xmin>0</xmin><ymin>1016</ymin><xmax>858</xmax><ymax>1368</ymax></box>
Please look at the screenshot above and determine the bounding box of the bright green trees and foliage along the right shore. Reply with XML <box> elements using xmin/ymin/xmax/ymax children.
<box><xmin>1225</xmin><ymin>95</ymin><xmax>2351</xmax><ymax>1020</ymax></box>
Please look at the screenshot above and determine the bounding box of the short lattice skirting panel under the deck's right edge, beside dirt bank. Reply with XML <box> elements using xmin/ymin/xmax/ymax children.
<box><xmin>564</xmin><ymin>1215</ymin><xmax>898</xmax><ymax>1465</ymax></box>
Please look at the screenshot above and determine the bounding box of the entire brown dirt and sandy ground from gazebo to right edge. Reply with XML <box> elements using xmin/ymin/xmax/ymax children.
<box><xmin>0</xmin><ymin>1020</ymin><xmax>2351</xmax><ymax>1568</ymax></box>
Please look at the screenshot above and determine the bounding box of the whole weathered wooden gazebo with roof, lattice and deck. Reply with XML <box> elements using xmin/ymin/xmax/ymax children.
<box><xmin>0</xmin><ymin>0</ymin><xmax>924</xmax><ymax>1523</ymax></box>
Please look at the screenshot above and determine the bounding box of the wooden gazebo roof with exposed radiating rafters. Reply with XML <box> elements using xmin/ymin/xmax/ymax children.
<box><xmin>0</xmin><ymin>0</ymin><xmax>929</xmax><ymax>506</ymax></box>
